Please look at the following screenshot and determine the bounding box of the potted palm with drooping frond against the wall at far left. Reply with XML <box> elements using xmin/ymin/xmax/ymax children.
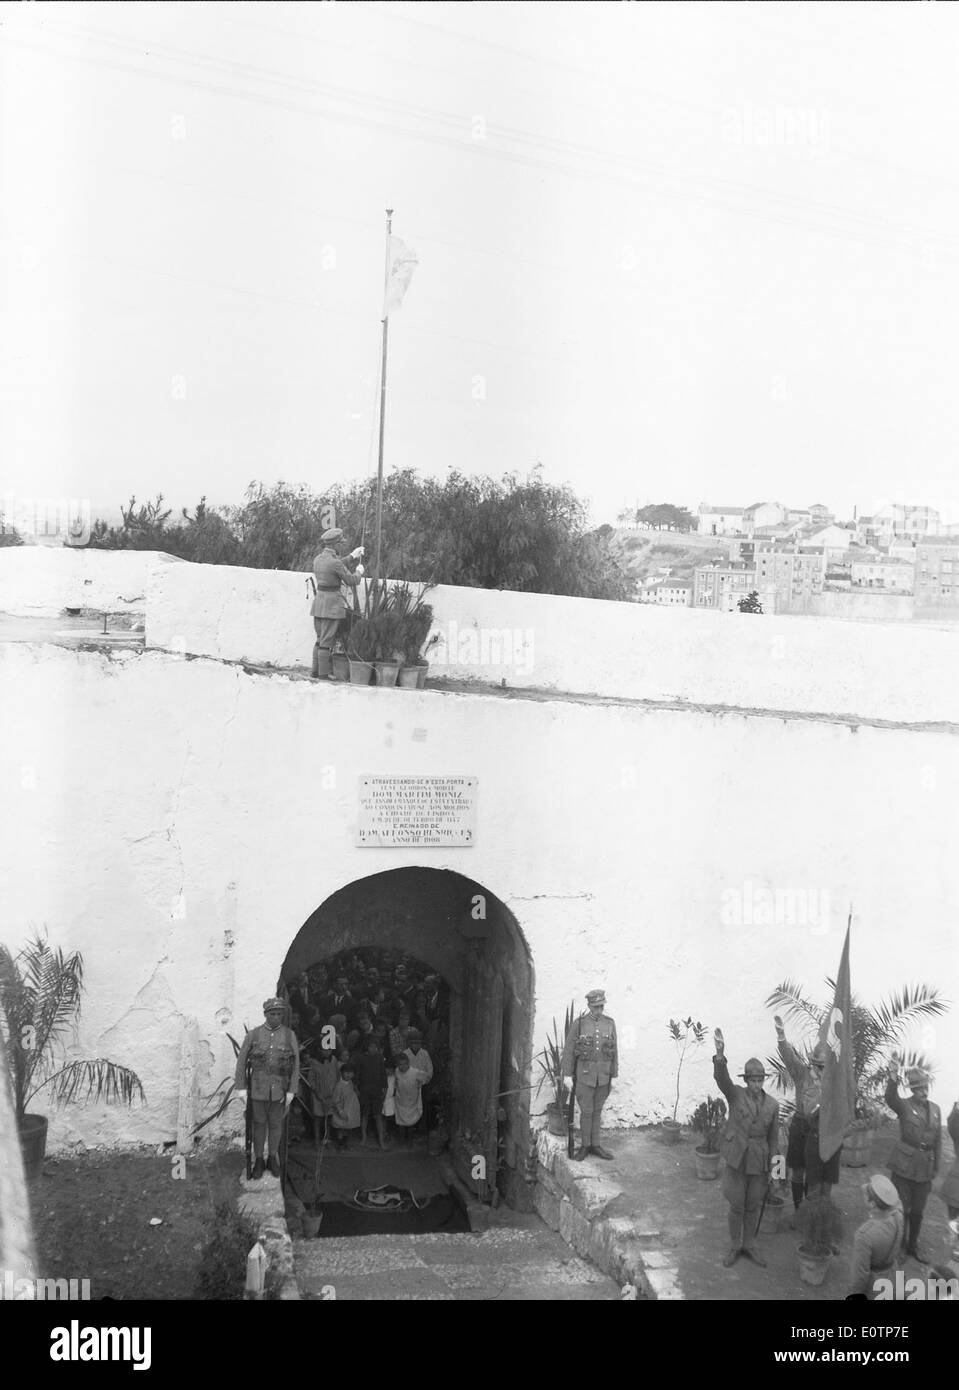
<box><xmin>0</xmin><ymin>933</ymin><xmax>143</xmax><ymax>1179</ymax></box>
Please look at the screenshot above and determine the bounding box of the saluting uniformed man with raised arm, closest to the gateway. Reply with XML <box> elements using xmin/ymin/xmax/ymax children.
<box><xmin>713</xmin><ymin>1029</ymin><xmax>780</xmax><ymax>1268</ymax></box>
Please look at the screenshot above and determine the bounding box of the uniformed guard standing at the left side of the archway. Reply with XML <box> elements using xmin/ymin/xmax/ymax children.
<box><xmin>233</xmin><ymin>998</ymin><xmax>300</xmax><ymax>1177</ymax></box>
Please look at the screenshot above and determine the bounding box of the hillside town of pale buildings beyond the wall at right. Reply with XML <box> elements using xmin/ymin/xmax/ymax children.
<box><xmin>624</xmin><ymin>502</ymin><xmax>959</xmax><ymax>621</ymax></box>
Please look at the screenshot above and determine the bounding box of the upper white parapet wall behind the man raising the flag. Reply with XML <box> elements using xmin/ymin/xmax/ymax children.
<box><xmin>146</xmin><ymin>564</ymin><xmax>959</xmax><ymax>721</ymax></box>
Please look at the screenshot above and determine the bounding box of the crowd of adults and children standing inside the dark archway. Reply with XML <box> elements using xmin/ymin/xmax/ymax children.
<box><xmin>285</xmin><ymin>947</ymin><xmax>449</xmax><ymax>1148</ymax></box>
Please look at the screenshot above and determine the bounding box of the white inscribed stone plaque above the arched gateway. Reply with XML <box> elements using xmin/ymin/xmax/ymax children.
<box><xmin>356</xmin><ymin>777</ymin><xmax>478</xmax><ymax>849</ymax></box>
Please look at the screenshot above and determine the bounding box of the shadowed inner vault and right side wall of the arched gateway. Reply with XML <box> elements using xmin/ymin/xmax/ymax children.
<box><xmin>279</xmin><ymin>867</ymin><xmax>532</xmax><ymax>1207</ymax></box>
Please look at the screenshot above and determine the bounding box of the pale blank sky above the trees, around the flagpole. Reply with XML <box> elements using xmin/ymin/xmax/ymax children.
<box><xmin>0</xmin><ymin>3</ymin><xmax>959</xmax><ymax>521</ymax></box>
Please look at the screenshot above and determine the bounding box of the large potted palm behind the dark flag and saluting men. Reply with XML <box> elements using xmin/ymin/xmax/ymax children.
<box><xmin>766</xmin><ymin>980</ymin><xmax>948</xmax><ymax>1168</ymax></box>
